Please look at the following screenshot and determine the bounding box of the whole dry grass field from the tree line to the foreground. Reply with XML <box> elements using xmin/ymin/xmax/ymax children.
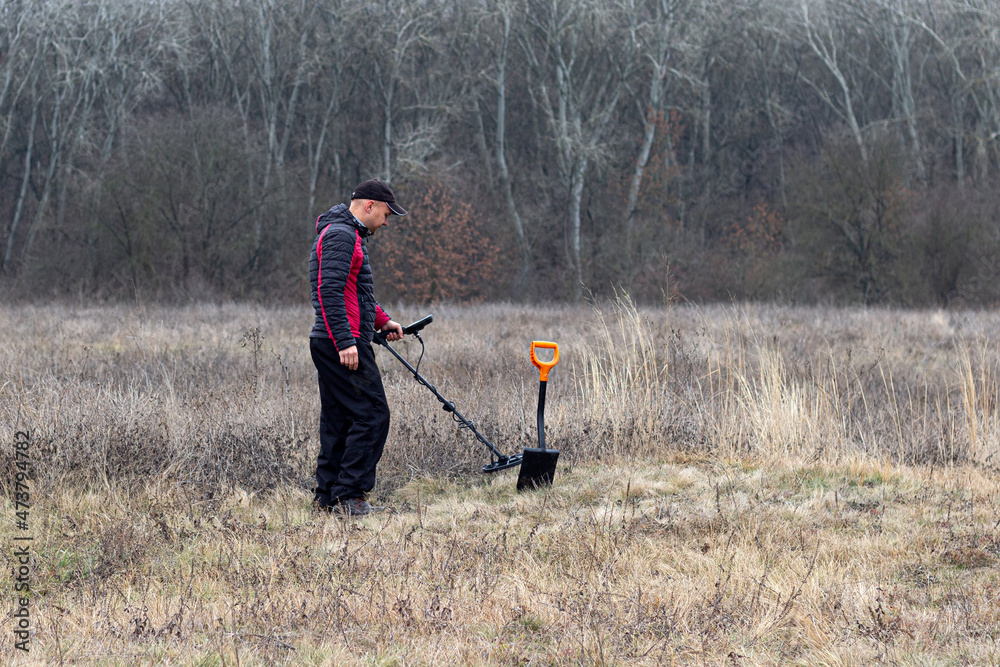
<box><xmin>0</xmin><ymin>299</ymin><xmax>1000</xmax><ymax>667</ymax></box>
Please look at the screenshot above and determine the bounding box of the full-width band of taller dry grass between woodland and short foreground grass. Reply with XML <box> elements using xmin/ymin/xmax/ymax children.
<box><xmin>0</xmin><ymin>296</ymin><xmax>1000</xmax><ymax>491</ymax></box>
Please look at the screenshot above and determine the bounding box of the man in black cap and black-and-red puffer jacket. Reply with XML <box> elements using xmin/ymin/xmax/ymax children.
<box><xmin>309</xmin><ymin>180</ymin><xmax>406</xmax><ymax>515</ymax></box>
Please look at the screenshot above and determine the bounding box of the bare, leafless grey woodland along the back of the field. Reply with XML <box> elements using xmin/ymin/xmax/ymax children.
<box><xmin>0</xmin><ymin>0</ymin><xmax>1000</xmax><ymax>305</ymax></box>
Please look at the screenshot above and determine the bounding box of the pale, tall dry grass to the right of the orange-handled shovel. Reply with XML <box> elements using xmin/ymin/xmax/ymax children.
<box><xmin>570</xmin><ymin>298</ymin><xmax>1000</xmax><ymax>467</ymax></box>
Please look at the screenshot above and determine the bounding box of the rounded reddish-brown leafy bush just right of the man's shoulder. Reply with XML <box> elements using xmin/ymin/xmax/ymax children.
<box><xmin>378</xmin><ymin>183</ymin><xmax>500</xmax><ymax>304</ymax></box>
